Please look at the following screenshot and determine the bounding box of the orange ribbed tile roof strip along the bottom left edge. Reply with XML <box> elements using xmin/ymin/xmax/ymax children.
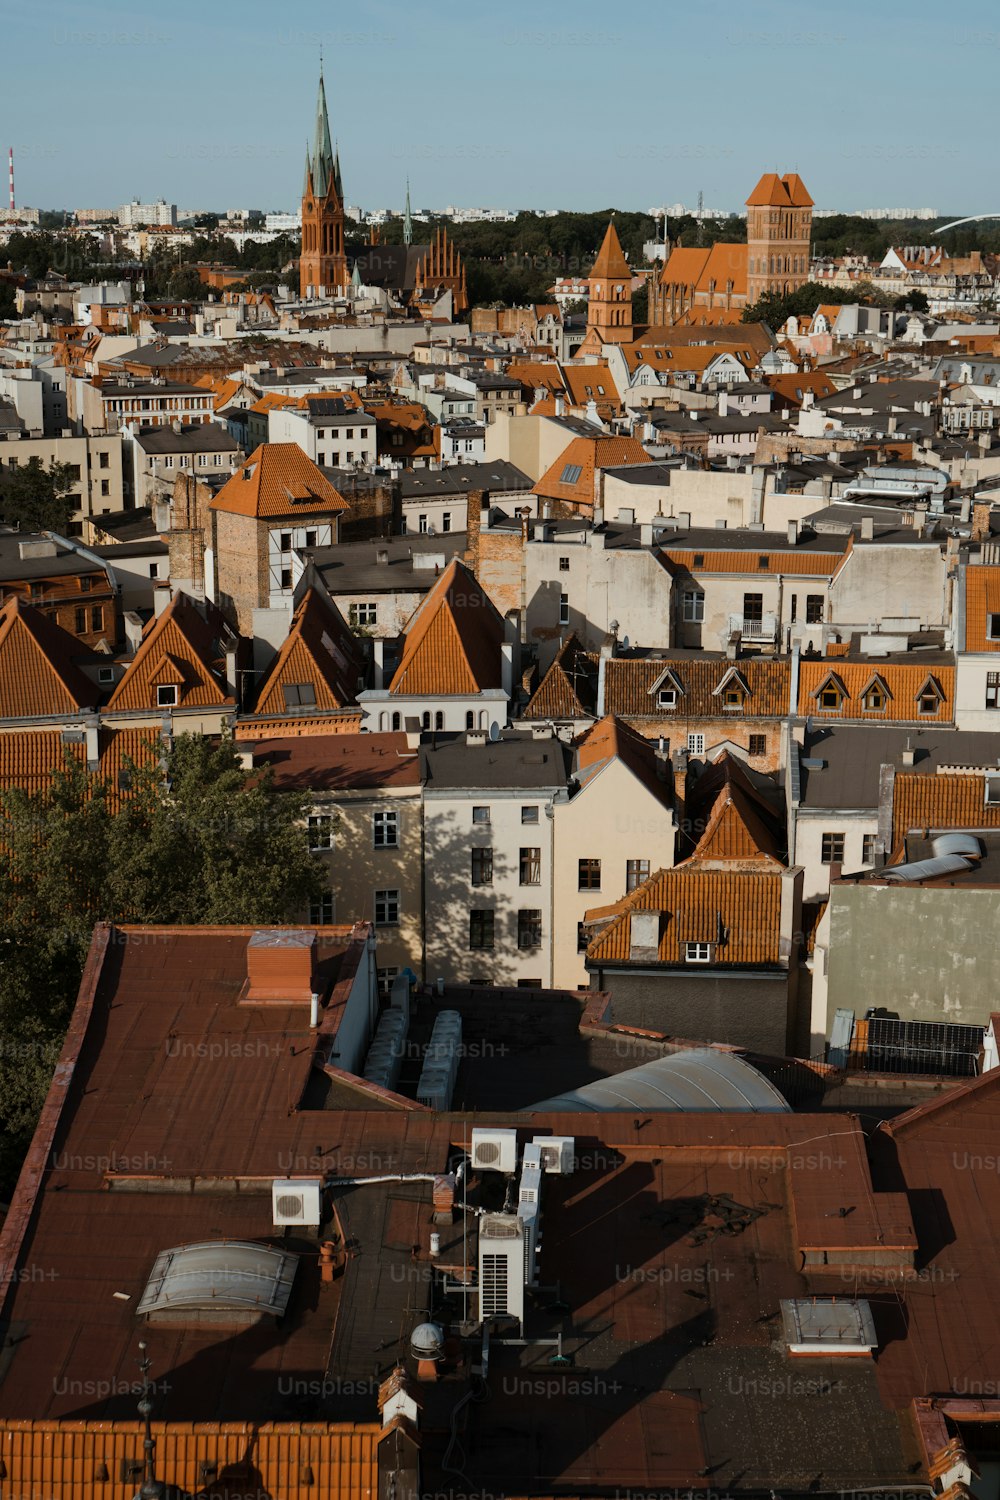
<box><xmin>0</xmin><ymin>1416</ymin><xmax>381</xmax><ymax>1500</ymax></box>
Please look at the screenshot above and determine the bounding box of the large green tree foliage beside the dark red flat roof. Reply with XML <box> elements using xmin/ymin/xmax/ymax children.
<box><xmin>0</xmin><ymin>735</ymin><xmax>325</xmax><ymax>1196</ymax></box>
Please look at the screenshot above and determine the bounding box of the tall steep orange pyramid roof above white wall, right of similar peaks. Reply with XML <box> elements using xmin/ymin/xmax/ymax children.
<box><xmin>390</xmin><ymin>558</ymin><xmax>504</xmax><ymax>695</ymax></box>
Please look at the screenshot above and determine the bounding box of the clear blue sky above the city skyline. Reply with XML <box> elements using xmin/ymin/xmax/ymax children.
<box><xmin>0</xmin><ymin>0</ymin><xmax>1000</xmax><ymax>215</ymax></box>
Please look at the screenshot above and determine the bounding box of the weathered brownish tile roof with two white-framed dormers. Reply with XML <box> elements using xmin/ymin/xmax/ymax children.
<box><xmin>604</xmin><ymin>657</ymin><xmax>792</xmax><ymax>723</ymax></box>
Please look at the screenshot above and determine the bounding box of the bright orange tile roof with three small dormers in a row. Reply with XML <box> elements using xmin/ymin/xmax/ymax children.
<box><xmin>796</xmin><ymin>656</ymin><xmax>955</xmax><ymax>725</ymax></box>
